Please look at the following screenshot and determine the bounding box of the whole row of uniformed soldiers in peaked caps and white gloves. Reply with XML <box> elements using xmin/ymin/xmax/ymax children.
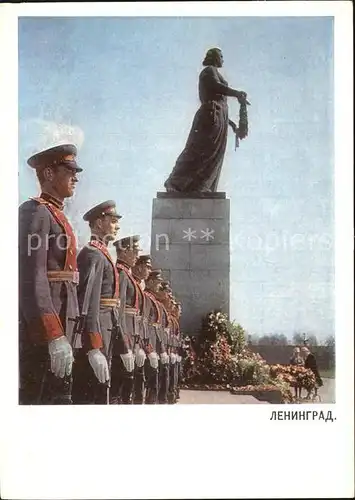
<box><xmin>19</xmin><ymin>144</ymin><xmax>186</xmax><ymax>404</ymax></box>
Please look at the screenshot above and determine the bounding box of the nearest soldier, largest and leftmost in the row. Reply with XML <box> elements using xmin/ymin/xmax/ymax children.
<box><xmin>19</xmin><ymin>144</ymin><xmax>82</xmax><ymax>404</ymax></box>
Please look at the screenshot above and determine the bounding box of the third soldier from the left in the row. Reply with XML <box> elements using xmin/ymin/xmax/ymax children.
<box><xmin>114</xmin><ymin>235</ymin><xmax>146</xmax><ymax>404</ymax></box>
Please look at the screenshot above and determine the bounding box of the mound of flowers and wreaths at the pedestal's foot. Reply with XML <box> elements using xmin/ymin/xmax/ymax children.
<box><xmin>181</xmin><ymin>311</ymin><xmax>304</xmax><ymax>403</ymax></box>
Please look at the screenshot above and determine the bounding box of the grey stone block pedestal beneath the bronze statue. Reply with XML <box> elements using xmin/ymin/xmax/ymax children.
<box><xmin>151</xmin><ymin>193</ymin><xmax>230</xmax><ymax>335</ymax></box>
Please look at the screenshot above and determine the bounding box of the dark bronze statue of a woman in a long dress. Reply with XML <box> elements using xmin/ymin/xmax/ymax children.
<box><xmin>164</xmin><ymin>48</ymin><xmax>249</xmax><ymax>193</ymax></box>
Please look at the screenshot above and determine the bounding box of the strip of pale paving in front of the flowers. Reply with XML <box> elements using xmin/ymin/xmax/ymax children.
<box><xmin>178</xmin><ymin>390</ymin><xmax>269</xmax><ymax>405</ymax></box>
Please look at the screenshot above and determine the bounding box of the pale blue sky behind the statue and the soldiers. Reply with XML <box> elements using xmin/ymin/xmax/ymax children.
<box><xmin>19</xmin><ymin>17</ymin><xmax>334</xmax><ymax>340</ymax></box>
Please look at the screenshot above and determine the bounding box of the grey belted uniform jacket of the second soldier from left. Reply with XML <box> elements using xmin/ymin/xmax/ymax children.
<box><xmin>78</xmin><ymin>240</ymin><xmax>128</xmax><ymax>357</ymax></box>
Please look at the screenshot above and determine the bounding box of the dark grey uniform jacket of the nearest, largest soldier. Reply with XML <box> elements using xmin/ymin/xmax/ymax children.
<box><xmin>19</xmin><ymin>193</ymin><xmax>78</xmax><ymax>348</ymax></box>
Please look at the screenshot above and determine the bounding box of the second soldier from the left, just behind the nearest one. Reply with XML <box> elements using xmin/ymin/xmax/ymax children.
<box><xmin>73</xmin><ymin>200</ymin><xmax>133</xmax><ymax>404</ymax></box>
